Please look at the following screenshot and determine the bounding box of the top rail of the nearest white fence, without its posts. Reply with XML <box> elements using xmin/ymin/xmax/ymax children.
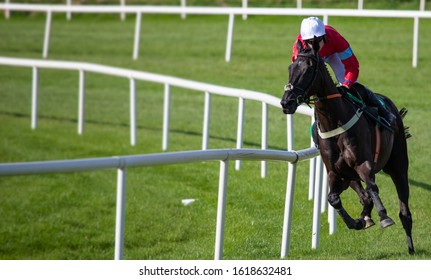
<box><xmin>0</xmin><ymin>148</ymin><xmax>319</xmax><ymax>176</ymax></box>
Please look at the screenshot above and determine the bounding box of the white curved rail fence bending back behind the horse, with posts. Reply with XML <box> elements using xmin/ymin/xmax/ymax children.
<box><xmin>0</xmin><ymin>57</ymin><xmax>335</xmax><ymax>258</ymax></box>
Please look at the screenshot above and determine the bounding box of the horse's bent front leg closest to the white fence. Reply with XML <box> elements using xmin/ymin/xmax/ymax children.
<box><xmin>328</xmin><ymin>171</ymin><xmax>365</xmax><ymax>230</ymax></box>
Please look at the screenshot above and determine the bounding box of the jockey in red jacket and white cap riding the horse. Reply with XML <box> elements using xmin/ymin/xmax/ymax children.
<box><xmin>292</xmin><ymin>17</ymin><xmax>395</xmax><ymax>127</ymax></box>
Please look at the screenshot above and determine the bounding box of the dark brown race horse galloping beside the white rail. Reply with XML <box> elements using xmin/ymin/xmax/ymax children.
<box><xmin>280</xmin><ymin>42</ymin><xmax>414</xmax><ymax>254</ymax></box>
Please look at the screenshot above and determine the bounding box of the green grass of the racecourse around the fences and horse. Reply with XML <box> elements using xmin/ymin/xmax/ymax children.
<box><xmin>0</xmin><ymin>5</ymin><xmax>431</xmax><ymax>259</ymax></box>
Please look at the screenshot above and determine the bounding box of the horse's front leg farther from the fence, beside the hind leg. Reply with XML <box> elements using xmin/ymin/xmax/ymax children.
<box><xmin>357</xmin><ymin>162</ymin><xmax>395</xmax><ymax>228</ymax></box>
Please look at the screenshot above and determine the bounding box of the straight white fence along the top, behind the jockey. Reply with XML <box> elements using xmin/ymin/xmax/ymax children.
<box><xmin>0</xmin><ymin>2</ymin><xmax>431</xmax><ymax>68</ymax></box>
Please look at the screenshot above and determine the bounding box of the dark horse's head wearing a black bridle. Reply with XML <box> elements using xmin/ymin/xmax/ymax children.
<box><xmin>280</xmin><ymin>40</ymin><xmax>320</xmax><ymax>114</ymax></box>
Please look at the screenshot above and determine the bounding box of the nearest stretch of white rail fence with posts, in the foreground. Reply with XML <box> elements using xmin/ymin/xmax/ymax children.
<box><xmin>0</xmin><ymin>148</ymin><xmax>326</xmax><ymax>260</ymax></box>
